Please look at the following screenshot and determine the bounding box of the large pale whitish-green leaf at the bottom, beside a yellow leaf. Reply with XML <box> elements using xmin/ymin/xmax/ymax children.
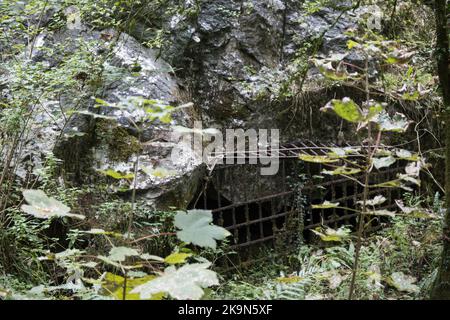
<box><xmin>131</xmin><ymin>263</ymin><xmax>219</xmax><ymax>300</ymax></box>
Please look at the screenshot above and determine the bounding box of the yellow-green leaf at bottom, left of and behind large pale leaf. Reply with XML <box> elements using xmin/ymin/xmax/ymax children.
<box><xmin>102</xmin><ymin>272</ymin><xmax>165</xmax><ymax>300</ymax></box>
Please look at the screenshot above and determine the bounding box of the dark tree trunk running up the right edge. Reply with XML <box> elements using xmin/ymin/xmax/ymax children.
<box><xmin>431</xmin><ymin>0</ymin><xmax>450</xmax><ymax>300</ymax></box>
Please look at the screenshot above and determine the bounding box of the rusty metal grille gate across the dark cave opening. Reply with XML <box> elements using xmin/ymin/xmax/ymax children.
<box><xmin>191</xmin><ymin>141</ymin><xmax>405</xmax><ymax>255</ymax></box>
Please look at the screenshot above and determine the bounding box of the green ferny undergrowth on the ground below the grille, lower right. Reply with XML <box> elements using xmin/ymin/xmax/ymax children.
<box><xmin>211</xmin><ymin>197</ymin><xmax>442</xmax><ymax>300</ymax></box>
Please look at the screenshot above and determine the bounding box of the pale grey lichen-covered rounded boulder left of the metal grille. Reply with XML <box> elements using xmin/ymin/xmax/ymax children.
<box><xmin>7</xmin><ymin>29</ymin><xmax>203</xmax><ymax>209</ymax></box>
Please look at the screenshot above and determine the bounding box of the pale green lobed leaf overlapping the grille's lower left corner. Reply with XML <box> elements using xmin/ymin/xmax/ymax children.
<box><xmin>174</xmin><ymin>210</ymin><xmax>231</xmax><ymax>249</ymax></box>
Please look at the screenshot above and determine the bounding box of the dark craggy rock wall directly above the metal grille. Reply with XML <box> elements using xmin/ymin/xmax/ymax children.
<box><xmin>158</xmin><ymin>0</ymin><xmax>362</xmax><ymax>141</ymax></box>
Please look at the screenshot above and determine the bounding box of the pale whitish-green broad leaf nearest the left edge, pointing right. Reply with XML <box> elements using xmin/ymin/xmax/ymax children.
<box><xmin>21</xmin><ymin>190</ymin><xmax>85</xmax><ymax>219</ymax></box>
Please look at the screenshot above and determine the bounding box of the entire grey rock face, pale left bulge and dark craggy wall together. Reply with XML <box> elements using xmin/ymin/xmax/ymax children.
<box><xmin>3</xmin><ymin>0</ymin><xmax>370</xmax><ymax>214</ymax></box>
